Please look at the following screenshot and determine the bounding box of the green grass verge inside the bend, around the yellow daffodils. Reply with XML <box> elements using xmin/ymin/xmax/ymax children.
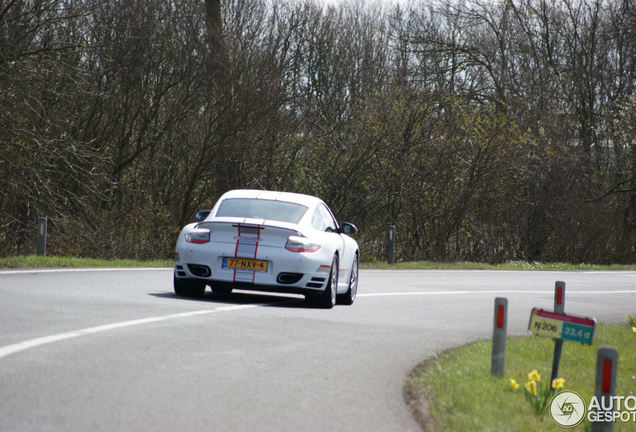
<box><xmin>405</xmin><ymin>317</ymin><xmax>636</xmax><ymax>432</ymax></box>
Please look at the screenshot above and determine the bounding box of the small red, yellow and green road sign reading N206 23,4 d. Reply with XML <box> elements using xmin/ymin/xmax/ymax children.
<box><xmin>528</xmin><ymin>308</ymin><xmax>596</xmax><ymax>345</ymax></box>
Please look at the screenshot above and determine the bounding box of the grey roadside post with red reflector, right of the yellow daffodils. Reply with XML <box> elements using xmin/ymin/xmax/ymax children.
<box><xmin>590</xmin><ymin>346</ymin><xmax>618</xmax><ymax>432</ymax></box>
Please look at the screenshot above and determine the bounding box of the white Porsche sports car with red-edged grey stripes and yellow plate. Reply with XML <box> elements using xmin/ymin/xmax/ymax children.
<box><xmin>174</xmin><ymin>190</ymin><xmax>360</xmax><ymax>308</ymax></box>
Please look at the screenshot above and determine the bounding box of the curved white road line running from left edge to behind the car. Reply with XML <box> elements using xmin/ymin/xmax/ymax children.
<box><xmin>0</xmin><ymin>303</ymin><xmax>260</xmax><ymax>359</ymax></box>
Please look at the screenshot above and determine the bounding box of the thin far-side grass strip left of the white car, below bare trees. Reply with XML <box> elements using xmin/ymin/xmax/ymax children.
<box><xmin>0</xmin><ymin>255</ymin><xmax>173</xmax><ymax>268</ymax></box>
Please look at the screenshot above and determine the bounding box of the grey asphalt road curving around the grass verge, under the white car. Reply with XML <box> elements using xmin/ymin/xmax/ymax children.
<box><xmin>0</xmin><ymin>269</ymin><xmax>636</xmax><ymax>432</ymax></box>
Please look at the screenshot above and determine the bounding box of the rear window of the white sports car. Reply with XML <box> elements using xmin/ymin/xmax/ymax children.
<box><xmin>216</xmin><ymin>198</ymin><xmax>307</xmax><ymax>223</ymax></box>
